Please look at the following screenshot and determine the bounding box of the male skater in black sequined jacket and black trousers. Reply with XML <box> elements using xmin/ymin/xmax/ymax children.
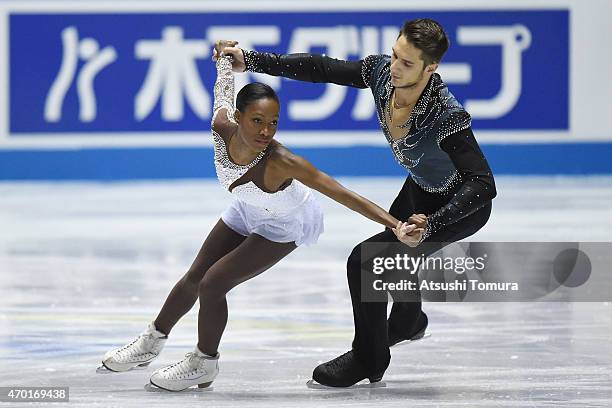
<box><xmin>224</xmin><ymin>19</ymin><xmax>496</xmax><ymax>387</ymax></box>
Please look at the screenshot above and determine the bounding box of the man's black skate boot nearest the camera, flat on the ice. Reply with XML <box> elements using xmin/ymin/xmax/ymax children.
<box><xmin>308</xmin><ymin>350</ymin><xmax>384</xmax><ymax>388</ymax></box>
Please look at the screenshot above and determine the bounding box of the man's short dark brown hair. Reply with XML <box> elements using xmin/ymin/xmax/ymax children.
<box><xmin>400</xmin><ymin>18</ymin><xmax>449</xmax><ymax>66</ymax></box>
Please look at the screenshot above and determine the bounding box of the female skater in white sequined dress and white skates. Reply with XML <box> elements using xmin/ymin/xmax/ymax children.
<box><xmin>102</xmin><ymin>42</ymin><xmax>425</xmax><ymax>391</ymax></box>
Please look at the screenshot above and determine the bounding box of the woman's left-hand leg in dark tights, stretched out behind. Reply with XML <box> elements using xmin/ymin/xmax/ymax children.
<box><xmin>155</xmin><ymin>220</ymin><xmax>246</xmax><ymax>334</ymax></box>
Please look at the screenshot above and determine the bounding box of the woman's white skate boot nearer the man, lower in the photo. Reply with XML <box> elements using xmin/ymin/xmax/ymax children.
<box><xmin>145</xmin><ymin>347</ymin><xmax>219</xmax><ymax>391</ymax></box>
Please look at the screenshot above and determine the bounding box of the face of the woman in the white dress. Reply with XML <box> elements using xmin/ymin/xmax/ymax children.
<box><xmin>236</xmin><ymin>98</ymin><xmax>280</xmax><ymax>151</ymax></box>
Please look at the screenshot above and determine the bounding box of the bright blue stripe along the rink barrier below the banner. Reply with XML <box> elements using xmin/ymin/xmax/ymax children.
<box><xmin>0</xmin><ymin>143</ymin><xmax>612</xmax><ymax>181</ymax></box>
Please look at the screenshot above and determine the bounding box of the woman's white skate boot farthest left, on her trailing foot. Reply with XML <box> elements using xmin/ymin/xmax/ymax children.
<box><xmin>98</xmin><ymin>323</ymin><xmax>168</xmax><ymax>372</ymax></box>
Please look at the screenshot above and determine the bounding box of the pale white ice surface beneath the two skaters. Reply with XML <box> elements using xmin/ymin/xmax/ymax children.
<box><xmin>0</xmin><ymin>177</ymin><xmax>612</xmax><ymax>408</ymax></box>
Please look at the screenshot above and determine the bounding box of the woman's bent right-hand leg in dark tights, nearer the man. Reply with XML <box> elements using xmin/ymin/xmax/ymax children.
<box><xmin>198</xmin><ymin>234</ymin><xmax>297</xmax><ymax>356</ymax></box>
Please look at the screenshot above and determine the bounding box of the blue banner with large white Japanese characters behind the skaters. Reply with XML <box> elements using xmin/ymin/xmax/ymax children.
<box><xmin>9</xmin><ymin>10</ymin><xmax>569</xmax><ymax>137</ymax></box>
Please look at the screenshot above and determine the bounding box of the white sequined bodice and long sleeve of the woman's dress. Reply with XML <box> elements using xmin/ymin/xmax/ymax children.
<box><xmin>211</xmin><ymin>58</ymin><xmax>311</xmax><ymax>216</ymax></box>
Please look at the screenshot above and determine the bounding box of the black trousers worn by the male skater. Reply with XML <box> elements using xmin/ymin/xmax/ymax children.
<box><xmin>347</xmin><ymin>177</ymin><xmax>491</xmax><ymax>374</ymax></box>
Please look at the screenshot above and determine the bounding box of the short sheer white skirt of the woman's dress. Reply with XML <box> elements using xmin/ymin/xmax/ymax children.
<box><xmin>221</xmin><ymin>194</ymin><xmax>323</xmax><ymax>246</ymax></box>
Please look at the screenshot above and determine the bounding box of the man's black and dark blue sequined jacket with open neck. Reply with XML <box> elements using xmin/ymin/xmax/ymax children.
<box><xmin>243</xmin><ymin>50</ymin><xmax>496</xmax><ymax>238</ymax></box>
